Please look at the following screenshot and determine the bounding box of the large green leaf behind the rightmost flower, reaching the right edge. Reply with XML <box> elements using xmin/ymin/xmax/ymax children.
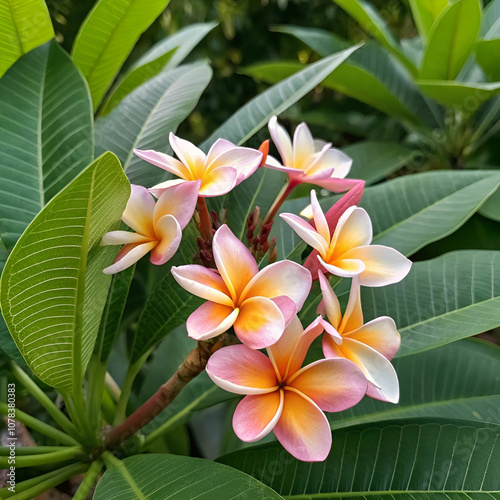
<box><xmin>274</xmin><ymin>170</ymin><xmax>500</xmax><ymax>258</ymax></box>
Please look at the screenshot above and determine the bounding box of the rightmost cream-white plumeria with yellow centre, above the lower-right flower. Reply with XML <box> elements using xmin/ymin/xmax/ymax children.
<box><xmin>280</xmin><ymin>190</ymin><xmax>411</xmax><ymax>286</ymax></box>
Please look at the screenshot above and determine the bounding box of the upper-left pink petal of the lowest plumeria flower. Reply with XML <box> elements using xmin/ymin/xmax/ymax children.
<box><xmin>207</xmin><ymin>345</ymin><xmax>278</xmax><ymax>394</ymax></box>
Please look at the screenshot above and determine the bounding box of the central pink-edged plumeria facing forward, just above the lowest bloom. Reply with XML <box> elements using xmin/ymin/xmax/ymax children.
<box><xmin>172</xmin><ymin>225</ymin><xmax>312</xmax><ymax>349</ymax></box>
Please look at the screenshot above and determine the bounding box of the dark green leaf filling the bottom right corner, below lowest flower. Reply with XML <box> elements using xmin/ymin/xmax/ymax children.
<box><xmin>218</xmin><ymin>420</ymin><xmax>500</xmax><ymax>500</ymax></box>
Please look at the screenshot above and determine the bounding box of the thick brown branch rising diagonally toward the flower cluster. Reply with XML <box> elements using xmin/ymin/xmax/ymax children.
<box><xmin>106</xmin><ymin>334</ymin><xmax>236</xmax><ymax>449</ymax></box>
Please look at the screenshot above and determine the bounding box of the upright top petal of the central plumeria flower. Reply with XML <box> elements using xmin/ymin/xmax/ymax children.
<box><xmin>212</xmin><ymin>224</ymin><xmax>258</xmax><ymax>301</ymax></box>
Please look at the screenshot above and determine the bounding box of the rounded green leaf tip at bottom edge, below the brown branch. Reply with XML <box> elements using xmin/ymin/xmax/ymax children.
<box><xmin>94</xmin><ymin>454</ymin><xmax>281</xmax><ymax>500</ymax></box>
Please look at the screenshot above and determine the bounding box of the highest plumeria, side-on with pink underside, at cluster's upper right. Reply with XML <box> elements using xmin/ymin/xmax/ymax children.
<box><xmin>265</xmin><ymin>116</ymin><xmax>363</xmax><ymax>193</ymax></box>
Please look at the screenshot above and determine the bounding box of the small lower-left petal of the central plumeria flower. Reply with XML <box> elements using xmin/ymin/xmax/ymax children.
<box><xmin>186</xmin><ymin>302</ymin><xmax>238</xmax><ymax>340</ymax></box>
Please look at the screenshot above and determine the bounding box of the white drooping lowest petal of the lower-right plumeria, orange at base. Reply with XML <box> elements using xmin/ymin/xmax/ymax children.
<box><xmin>341</xmin><ymin>337</ymin><xmax>399</xmax><ymax>403</ymax></box>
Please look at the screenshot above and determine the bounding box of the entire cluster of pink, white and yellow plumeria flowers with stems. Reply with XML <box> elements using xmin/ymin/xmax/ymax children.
<box><xmin>101</xmin><ymin>117</ymin><xmax>411</xmax><ymax>461</ymax></box>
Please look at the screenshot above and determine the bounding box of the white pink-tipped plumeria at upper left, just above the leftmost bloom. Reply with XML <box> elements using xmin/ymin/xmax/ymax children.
<box><xmin>134</xmin><ymin>133</ymin><xmax>263</xmax><ymax>197</ymax></box>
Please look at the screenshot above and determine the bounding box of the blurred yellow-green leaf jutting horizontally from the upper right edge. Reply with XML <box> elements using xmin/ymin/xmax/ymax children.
<box><xmin>417</xmin><ymin>75</ymin><xmax>500</xmax><ymax>110</ymax></box>
